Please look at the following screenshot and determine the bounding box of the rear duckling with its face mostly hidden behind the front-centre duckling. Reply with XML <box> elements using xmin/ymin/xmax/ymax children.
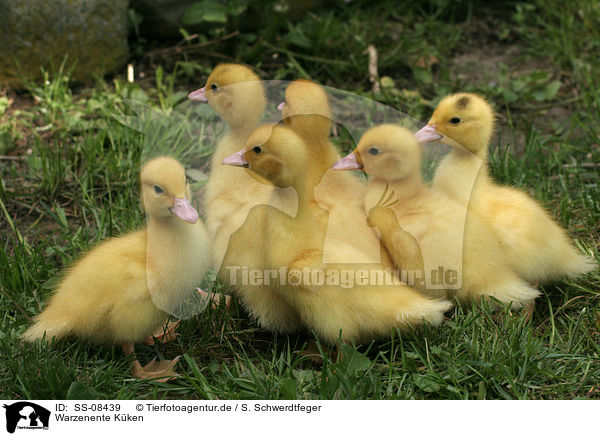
<box><xmin>278</xmin><ymin>79</ymin><xmax>382</xmax><ymax>266</ymax></box>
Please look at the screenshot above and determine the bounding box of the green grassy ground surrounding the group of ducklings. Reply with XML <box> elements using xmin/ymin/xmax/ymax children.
<box><xmin>0</xmin><ymin>0</ymin><xmax>600</xmax><ymax>399</ymax></box>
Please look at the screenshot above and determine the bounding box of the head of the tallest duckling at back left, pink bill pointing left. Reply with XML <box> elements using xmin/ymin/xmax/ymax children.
<box><xmin>188</xmin><ymin>64</ymin><xmax>266</xmax><ymax>127</ymax></box>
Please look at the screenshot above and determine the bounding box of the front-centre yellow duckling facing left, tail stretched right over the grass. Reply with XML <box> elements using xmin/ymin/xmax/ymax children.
<box><xmin>226</xmin><ymin>125</ymin><xmax>451</xmax><ymax>343</ymax></box>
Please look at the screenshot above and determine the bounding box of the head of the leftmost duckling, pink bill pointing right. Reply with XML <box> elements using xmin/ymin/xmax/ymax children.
<box><xmin>140</xmin><ymin>156</ymin><xmax>198</xmax><ymax>224</ymax></box>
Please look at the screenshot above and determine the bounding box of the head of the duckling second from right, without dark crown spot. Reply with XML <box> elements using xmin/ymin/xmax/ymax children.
<box><xmin>332</xmin><ymin>124</ymin><xmax>421</xmax><ymax>181</ymax></box>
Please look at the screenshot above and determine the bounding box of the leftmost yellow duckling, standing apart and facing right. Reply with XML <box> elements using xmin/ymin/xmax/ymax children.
<box><xmin>22</xmin><ymin>156</ymin><xmax>210</xmax><ymax>381</ymax></box>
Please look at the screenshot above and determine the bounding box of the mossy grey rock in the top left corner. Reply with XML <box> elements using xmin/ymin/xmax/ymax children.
<box><xmin>0</xmin><ymin>0</ymin><xmax>128</xmax><ymax>87</ymax></box>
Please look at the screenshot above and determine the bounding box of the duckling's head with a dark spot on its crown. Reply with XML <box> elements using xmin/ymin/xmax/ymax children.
<box><xmin>415</xmin><ymin>92</ymin><xmax>495</xmax><ymax>157</ymax></box>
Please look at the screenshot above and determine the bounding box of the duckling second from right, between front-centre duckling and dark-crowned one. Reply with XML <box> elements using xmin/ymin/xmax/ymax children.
<box><xmin>336</xmin><ymin>124</ymin><xmax>538</xmax><ymax>307</ymax></box>
